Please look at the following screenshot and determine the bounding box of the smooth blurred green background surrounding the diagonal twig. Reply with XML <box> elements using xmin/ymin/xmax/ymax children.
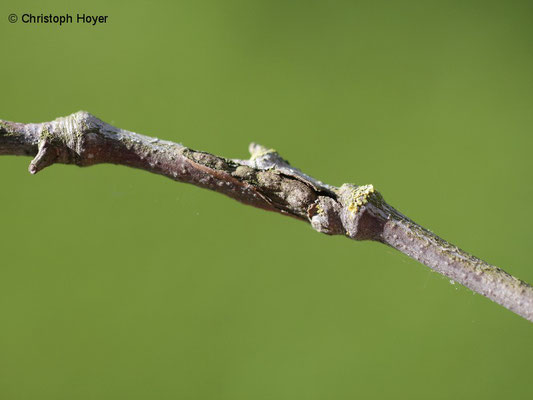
<box><xmin>0</xmin><ymin>0</ymin><xmax>533</xmax><ymax>400</ymax></box>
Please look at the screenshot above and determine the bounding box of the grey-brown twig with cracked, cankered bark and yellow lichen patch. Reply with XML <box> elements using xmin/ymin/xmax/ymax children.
<box><xmin>0</xmin><ymin>111</ymin><xmax>533</xmax><ymax>322</ymax></box>
